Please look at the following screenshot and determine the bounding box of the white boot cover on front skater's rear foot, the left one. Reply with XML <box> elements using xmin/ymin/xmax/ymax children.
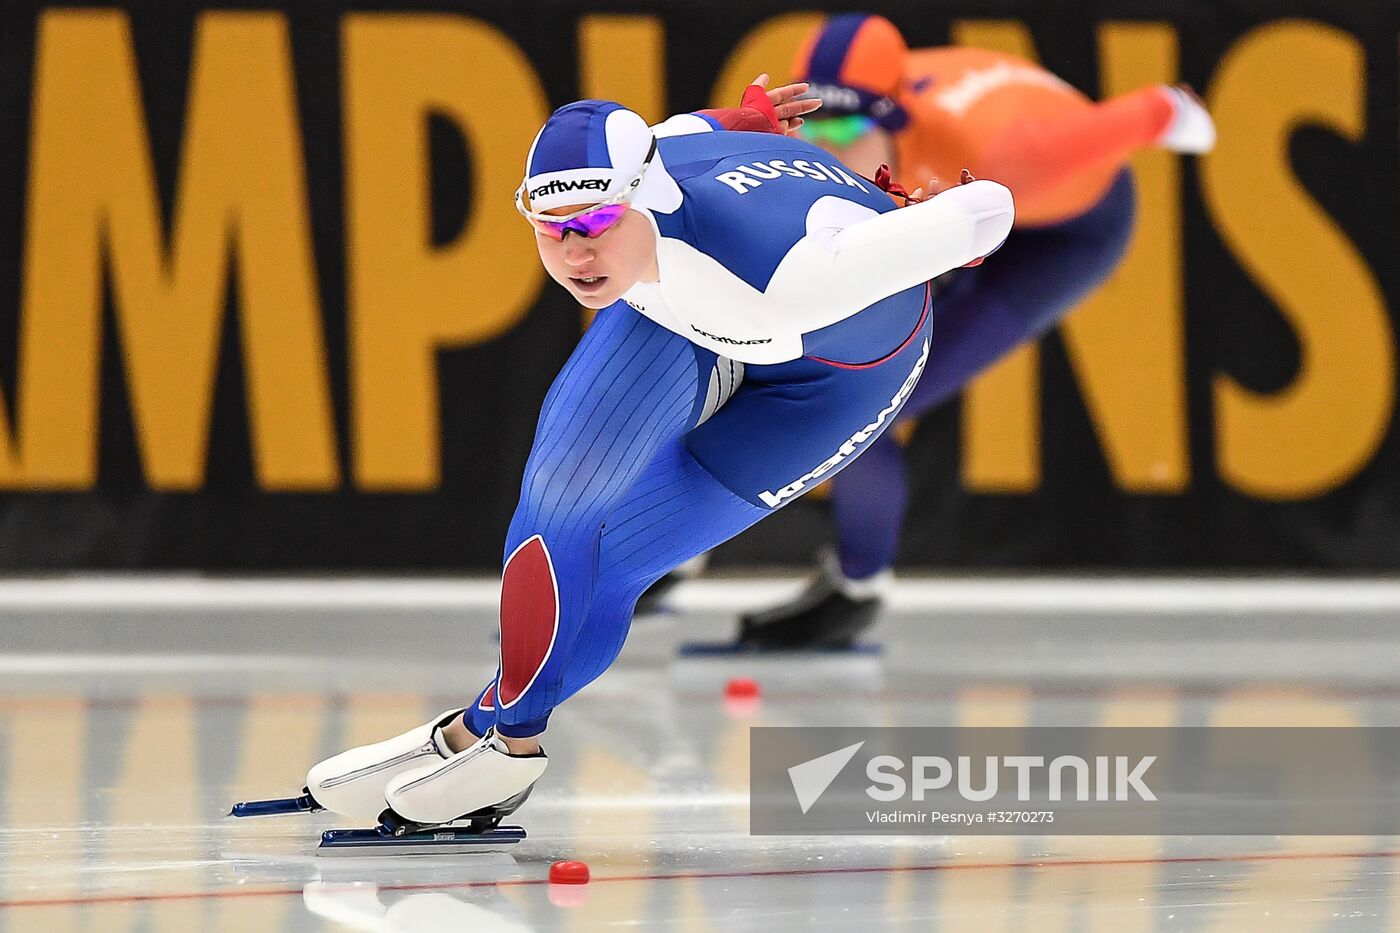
<box><xmin>307</xmin><ymin>709</ymin><xmax>462</xmax><ymax>824</ymax></box>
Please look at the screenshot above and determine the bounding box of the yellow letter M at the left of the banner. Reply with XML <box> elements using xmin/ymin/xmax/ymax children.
<box><xmin>18</xmin><ymin>11</ymin><xmax>337</xmax><ymax>489</ymax></box>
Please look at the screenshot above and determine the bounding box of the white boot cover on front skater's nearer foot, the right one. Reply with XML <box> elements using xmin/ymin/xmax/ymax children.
<box><xmin>382</xmin><ymin>728</ymin><xmax>549</xmax><ymax>824</ymax></box>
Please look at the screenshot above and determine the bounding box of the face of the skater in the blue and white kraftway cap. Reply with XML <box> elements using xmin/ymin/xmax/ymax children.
<box><xmin>535</xmin><ymin>205</ymin><xmax>658</xmax><ymax>308</ymax></box>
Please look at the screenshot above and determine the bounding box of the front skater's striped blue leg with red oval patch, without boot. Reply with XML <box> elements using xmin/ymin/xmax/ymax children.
<box><xmin>468</xmin><ymin>304</ymin><xmax>714</xmax><ymax>740</ymax></box>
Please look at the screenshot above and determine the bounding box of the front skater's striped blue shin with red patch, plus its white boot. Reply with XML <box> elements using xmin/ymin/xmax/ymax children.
<box><xmin>372</xmin><ymin>303</ymin><xmax>714</xmax><ymax>825</ymax></box>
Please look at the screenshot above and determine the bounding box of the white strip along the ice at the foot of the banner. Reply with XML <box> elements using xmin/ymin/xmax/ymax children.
<box><xmin>8</xmin><ymin>576</ymin><xmax>1400</xmax><ymax>614</ymax></box>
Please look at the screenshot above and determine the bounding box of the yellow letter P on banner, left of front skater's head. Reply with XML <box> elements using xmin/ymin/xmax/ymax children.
<box><xmin>343</xmin><ymin>14</ymin><xmax>547</xmax><ymax>490</ymax></box>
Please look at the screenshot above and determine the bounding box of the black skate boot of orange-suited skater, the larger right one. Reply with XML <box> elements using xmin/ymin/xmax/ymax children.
<box><xmin>739</xmin><ymin>558</ymin><xmax>889</xmax><ymax>651</ymax></box>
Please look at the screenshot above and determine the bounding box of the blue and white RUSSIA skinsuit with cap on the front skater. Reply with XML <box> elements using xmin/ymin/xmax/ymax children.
<box><xmin>466</xmin><ymin>101</ymin><xmax>1012</xmax><ymax>737</ymax></box>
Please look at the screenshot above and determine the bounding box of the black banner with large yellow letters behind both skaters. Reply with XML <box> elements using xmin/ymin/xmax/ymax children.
<box><xmin>0</xmin><ymin>0</ymin><xmax>1400</xmax><ymax>570</ymax></box>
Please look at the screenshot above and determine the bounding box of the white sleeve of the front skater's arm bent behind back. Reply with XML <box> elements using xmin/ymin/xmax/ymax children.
<box><xmin>764</xmin><ymin>181</ymin><xmax>1015</xmax><ymax>331</ymax></box>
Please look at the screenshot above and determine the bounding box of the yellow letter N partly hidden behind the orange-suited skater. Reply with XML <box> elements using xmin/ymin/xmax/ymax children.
<box><xmin>953</xmin><ymin>21</ymin><xmax>1190</xmax><ymax>492</ymax></box>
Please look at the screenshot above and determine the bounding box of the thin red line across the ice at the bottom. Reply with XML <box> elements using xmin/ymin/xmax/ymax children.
<box><xmin>0</xmin><ymin>849</ymin><xmax>1400</xmax><ymax>911</ymax></box>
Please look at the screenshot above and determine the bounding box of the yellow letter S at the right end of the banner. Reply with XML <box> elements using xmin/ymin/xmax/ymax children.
<box><xmin>1201</xmin><ymin>21</ymin><xmax>1394</xmax><ymax>499</ymax></box>
